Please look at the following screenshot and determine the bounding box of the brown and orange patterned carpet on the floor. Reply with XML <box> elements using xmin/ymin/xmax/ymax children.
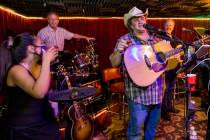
<box><xmin>101</xmin><ymin>97</ymin><xmax>207</xmax><ymax>140</ymax></box>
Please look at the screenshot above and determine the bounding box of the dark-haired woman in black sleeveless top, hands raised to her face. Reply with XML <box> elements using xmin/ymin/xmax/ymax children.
<box><xmin>6</xmin><ymin>33</ymin><xmax>60</xmax><ymax>140</ymax></box>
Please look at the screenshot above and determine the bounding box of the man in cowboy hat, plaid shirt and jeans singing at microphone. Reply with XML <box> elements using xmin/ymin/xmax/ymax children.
<box><xmin>109</xmin><ymin>7</ymin><xmax>163</xmax><ymax>140</ymax></box>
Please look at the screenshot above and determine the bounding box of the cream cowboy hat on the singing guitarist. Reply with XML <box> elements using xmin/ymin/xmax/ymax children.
<box><xmin>124</xmin><ymin>7</ymin><xmax>148</xmax><ymax>27</ymax></box>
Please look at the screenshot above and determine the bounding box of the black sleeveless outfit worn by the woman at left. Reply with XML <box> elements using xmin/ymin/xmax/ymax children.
<box><xmin>5</xmin><ymin>66</ymin><xmax>60</xmax><ymax>140</ymax></box>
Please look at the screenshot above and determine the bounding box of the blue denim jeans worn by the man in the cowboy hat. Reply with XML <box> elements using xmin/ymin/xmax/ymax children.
<box><xmin>127</xmin><ymin>101</ymin><xmax>161</xmax><ymax>140</ymax></box>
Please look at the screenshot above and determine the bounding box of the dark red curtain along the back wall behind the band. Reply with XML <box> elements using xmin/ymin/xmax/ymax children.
<box><xmin>0</xmin><ymin>9</ymin><xmax>210</xmax><ymax>69</ymax></box>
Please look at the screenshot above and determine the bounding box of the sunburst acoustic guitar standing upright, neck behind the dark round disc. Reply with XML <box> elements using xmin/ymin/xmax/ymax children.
<box><xmin>58</xmin><ymin>65</ymin><xmax>94</xmax><ymax>140</ymax></box>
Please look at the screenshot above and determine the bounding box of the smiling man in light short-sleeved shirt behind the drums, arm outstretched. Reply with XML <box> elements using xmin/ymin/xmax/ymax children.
<box><xmin>37</xmin><ymin>12</ymin><xmax>95</xmax><ymax>51</ymax></box>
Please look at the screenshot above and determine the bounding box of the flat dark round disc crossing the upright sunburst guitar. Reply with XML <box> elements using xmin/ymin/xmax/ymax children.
<box><xmin>48</xmin><ymin>87</ymin><xmax>97</xmax><ymax>102</ymax></box>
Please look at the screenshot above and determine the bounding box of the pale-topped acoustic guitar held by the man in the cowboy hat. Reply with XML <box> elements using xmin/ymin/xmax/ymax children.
<box><xmin>124</xmin><ymin>40</ymin><xmax>183</xmax><ymax>87</ymax></box>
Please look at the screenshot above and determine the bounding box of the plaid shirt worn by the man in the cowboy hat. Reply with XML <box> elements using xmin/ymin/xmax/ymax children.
<box><xmin>115</xmin><ymin>33</ymin><xmax>164</xmax><ymax>105</ymax></box>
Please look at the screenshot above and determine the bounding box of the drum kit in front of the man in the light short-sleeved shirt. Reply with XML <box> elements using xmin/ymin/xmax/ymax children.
<box><xmin>52</xmin><ymin>42</ymin><xmax>99</xmax><ymax>90</ymax></box>
